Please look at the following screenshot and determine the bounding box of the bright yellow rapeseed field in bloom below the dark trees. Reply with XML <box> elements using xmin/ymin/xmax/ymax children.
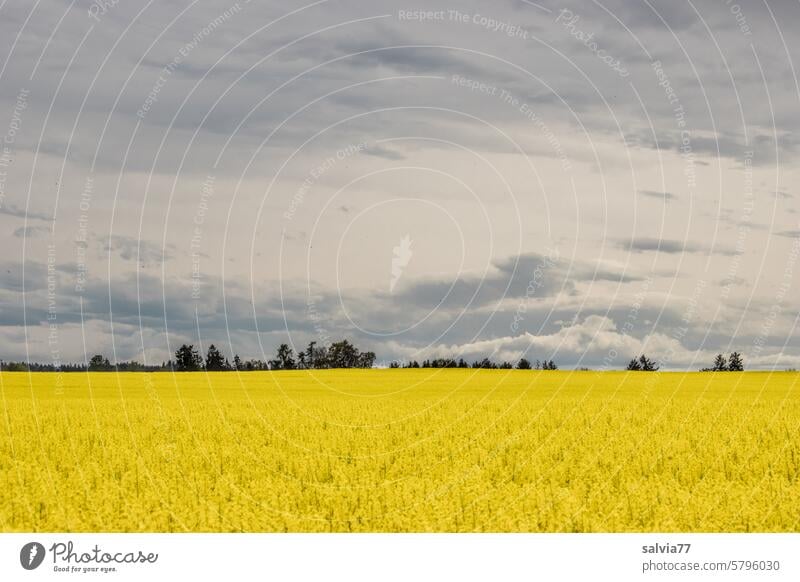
<box><xmin>0</xmin><ymin>369</ymin><xmax>800</xmax><ymax>532</ymax></box>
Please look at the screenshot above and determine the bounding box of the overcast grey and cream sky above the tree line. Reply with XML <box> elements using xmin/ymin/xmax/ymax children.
<box><xmin>0</xmin><ymin>0</ymin><xmax>800</xmax><ymax>369</ymax></box>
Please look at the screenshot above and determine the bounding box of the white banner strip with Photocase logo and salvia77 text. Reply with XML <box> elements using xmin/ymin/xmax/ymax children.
<box><xmin>0</xmin><ymin>533</ymin><xmax>800</xmax><ymax>582</ymax></box>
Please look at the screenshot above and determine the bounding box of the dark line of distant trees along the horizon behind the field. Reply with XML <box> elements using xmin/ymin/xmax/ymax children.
<box><xmin>0</xmin><ymin>340</ymin><xmax>744</xmax><ymax>372</ymax></box>
